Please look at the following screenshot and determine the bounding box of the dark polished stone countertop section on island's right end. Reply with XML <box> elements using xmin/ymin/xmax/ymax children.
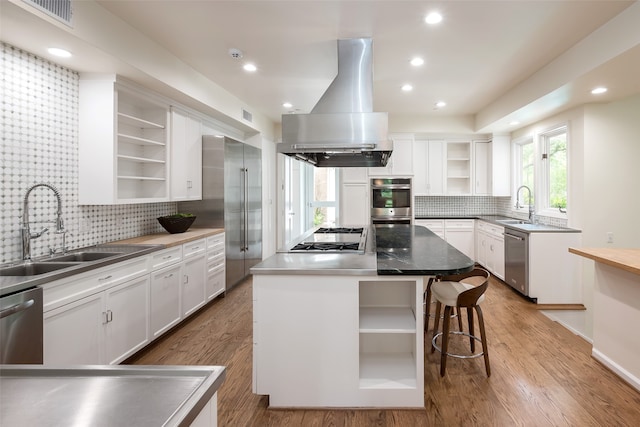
<box><xmin>374</xmin><ymin>225</ymin><xmax>475</xmax><ymax>276</ymax></box>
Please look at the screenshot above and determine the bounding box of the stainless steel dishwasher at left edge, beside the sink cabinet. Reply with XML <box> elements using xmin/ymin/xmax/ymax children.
<box><xmin>0</xmin><ymin>288</ymin><xmax>44</xmax><ymax>364</ymax></box>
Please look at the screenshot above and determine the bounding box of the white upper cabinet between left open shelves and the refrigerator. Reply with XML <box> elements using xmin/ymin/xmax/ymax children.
<box><xmin>170</xmin><ymin>107</ymin><xmax>202</xmax><ymax>201</ymax></box>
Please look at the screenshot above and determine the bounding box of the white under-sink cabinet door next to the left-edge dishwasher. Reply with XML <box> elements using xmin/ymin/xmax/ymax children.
<box><xmin>44</xmin><ymin>293</ymin><xmax>105</xmax><ymax>365</ymax></box>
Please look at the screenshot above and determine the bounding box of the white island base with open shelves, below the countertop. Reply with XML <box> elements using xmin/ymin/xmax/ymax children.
<box><xmin>253</xmin><ymin>275</ymin><xmax>424</xmax><ymax>408</ymax></box>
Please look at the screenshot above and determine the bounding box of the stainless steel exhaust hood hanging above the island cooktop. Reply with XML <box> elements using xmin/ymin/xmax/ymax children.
<box><xmin>277</xmin><ymin>39</ymin><xmax>393</xmax><ymax>167</ymax></box>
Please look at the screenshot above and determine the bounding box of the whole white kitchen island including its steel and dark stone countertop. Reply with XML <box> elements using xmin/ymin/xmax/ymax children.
<box><xmin>251</xmin><ymin>225</ymin><xmax>474</xmax><ymax>408</ymax></box>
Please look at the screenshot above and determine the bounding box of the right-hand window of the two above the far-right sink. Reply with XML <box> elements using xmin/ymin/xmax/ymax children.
<box><xmin>538</xmin><ymin>126</ymin><xmax>568</xmax><ymax>215</ymax></box>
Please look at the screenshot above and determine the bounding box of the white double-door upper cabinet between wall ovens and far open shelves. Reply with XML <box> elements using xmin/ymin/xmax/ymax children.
<box><xmin>413</xmin><ymin>140</ymin><xmax>446</xmax><ymax>196</ymax></box>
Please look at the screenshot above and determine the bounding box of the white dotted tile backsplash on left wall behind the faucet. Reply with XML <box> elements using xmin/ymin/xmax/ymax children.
<box><xmin>0</xmin><ymin>43</ymin><xmax>177</xmax><ymax>264</ymax></box>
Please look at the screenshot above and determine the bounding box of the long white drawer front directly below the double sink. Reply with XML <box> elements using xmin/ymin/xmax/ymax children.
<box><xmin>43</xmin><ymin>256</ymin><xmax>149</xmax><ymax>312</ymax></box>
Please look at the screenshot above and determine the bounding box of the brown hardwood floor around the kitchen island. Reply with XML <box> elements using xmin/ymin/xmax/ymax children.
<box><xmin>126</xmin><ymin>278</ymin><xmax>640</xmax><ymax>427</ymax></box>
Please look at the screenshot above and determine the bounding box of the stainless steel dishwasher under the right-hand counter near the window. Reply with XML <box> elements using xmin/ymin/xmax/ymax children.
<box><xmin>504</xmin><ymin>228</ymin><xmax>529</xmax><ymax>296</ymax></box>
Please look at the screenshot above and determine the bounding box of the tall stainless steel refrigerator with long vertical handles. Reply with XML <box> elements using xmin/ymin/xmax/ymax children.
<box><xmin>178</xmin><ymin>135</ymin><xmax>262</xmax><ymax>289</ymax></box>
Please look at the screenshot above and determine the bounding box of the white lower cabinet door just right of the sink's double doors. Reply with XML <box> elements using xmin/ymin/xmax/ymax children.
<box><xmin>150</xmin><ymin>264</ymin><xmax>182</xmax><ymax>339</ymax></box>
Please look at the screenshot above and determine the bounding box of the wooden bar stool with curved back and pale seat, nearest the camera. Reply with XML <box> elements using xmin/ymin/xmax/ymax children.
<box><xmin>431</xmin><ymin>268</ymin><xmax>491</xmax><ymax>377</ymax></box>
